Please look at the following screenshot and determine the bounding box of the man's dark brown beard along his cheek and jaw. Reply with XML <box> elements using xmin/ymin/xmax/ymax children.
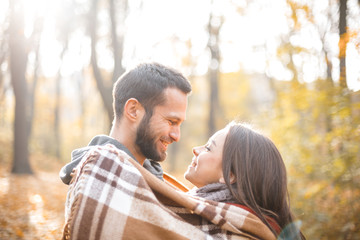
<box><xmin>135</xmin><ymin>113</ymin><xmax>166</xmax><ymax>162</ymax></box>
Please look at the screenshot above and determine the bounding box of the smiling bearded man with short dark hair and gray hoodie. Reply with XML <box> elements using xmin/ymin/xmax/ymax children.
<box><xmin>60</xmin><ymin>63</ymin><xmax>191</xmax><ymax>184</ymax></box>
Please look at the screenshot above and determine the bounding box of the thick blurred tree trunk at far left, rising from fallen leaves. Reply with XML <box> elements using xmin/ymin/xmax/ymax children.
<box><xmin>9</xmin><ymin>0</ymin><xmax>32</xmax><ymax>174</ymax></box>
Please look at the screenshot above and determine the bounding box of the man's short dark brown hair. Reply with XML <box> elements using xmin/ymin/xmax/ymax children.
<box><xmin>113</xmin><ymin>63</ymin><xmax>191</xmax><ymax>119</ymax></box>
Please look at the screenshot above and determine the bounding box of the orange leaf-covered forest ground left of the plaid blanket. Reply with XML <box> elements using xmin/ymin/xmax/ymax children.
<box><xmin>0</xmin><ymin>167</ymin><xmax>67</xmax><ymax>240</ymax></box>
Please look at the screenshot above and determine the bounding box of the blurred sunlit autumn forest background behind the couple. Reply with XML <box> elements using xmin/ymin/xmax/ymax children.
<box><xmin>0</xmin><ymin>0</ymin><xmax>360</xmax><ymax>239</ymax></box>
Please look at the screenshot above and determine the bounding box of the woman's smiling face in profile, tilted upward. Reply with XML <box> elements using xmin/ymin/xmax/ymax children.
<box><xmin>184</xmin><ymin>128</ymin><xmax>229</xmax><ymax>188</ymax></box>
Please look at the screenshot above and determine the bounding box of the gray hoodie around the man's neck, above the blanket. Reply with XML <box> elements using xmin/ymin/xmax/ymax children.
<box><xmin>59</xmin><ymin>135</ymin><xmax>163</xmax><ymax>184</ymax></box>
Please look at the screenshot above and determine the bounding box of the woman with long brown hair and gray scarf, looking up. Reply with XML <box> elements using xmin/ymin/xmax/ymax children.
<box><xmin>185</xmin><ymin>122</ymin><xmax>305</xmax><ymax>239</ymax></box>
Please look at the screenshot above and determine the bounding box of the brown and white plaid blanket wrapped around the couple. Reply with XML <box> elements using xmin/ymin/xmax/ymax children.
<box><xmin>63</xmin><ymin>145</ymin><xmax>275</xmax><ymax>240</ymax></box>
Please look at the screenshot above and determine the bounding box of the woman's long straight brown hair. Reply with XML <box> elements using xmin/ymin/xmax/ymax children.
<box><xmin>222</xmin><ymin>122</ymin><xmax>305</xmax><ymax>239</ymax></box>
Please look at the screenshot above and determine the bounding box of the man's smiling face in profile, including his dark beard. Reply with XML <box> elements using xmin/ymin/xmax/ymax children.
<box><xmin>135</xmin><ymin>88</ymin><xmax>187</xmax><ymax>161</ymax></box>
